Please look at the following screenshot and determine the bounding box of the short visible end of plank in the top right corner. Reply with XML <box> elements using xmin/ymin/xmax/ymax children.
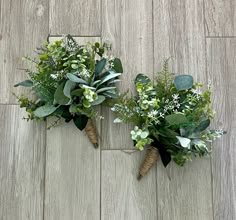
<box><xmin>204</xmin><ymin>0</ymin><xmax>236</xmax><ymax>37</ymax></box>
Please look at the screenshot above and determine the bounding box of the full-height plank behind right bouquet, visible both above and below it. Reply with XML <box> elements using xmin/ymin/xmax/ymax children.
<box><xmin>153</xmin><ymin>0</ymin><xmax>213</xmax><ymax>220</ymax></box>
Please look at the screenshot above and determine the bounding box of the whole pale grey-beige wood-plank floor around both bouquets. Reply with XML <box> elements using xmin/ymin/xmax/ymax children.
<box><xmin>0</xmin><ymin>0</ymin><xmax>236</xmax><ymax>220</ymax></box>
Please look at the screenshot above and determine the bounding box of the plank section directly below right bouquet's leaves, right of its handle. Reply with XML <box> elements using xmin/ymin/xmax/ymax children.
<box><xmin>157</xmin><ymin>158</ymin><xmax>213</xmax><ymax>220</ymax></box>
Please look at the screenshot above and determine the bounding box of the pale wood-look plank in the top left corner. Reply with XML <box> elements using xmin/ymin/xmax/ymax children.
<box><xmin>0</xmin><ymin>0</ymin><xmax>48</xmax><ymax>103</ymax></box>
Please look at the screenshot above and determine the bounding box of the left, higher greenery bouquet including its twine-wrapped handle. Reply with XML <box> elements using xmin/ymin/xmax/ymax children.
<box><xmin>15</xmin><ymin>35</ymin><xmax>123</xmax><ymax>147</ymax></box>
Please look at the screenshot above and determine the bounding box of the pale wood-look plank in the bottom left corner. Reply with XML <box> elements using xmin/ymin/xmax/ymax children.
<box><xmin>0</xmin><ymin>105</ymin><xmax>45</xmax><ymax>220</ymax></box>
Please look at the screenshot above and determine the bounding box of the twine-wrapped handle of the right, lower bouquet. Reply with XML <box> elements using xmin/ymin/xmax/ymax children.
<box><xmin>137</xmin><ymin>146</ymin><xmax>159</xmax><ymax>180</ymax></box>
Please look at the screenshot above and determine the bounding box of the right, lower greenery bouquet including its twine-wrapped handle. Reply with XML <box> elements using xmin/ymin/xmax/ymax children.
<box><xmin>112</xmin><ymin>60</ymin><xmax>225</xmax><ymax>179</ymax></box>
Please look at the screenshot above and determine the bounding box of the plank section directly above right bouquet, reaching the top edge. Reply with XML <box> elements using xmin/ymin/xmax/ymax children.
<box><xmin>153</xmin><ymin>0</ymin><xmax>207</xmax><ymax>82</ymax></box>
